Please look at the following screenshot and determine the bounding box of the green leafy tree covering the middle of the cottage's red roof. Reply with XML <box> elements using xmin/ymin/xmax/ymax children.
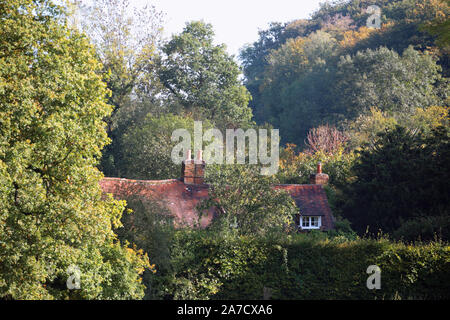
<box><xmin>199</xmin><ymin>165</ymin><xmax>298</xmax><ymax>235</ymax></box>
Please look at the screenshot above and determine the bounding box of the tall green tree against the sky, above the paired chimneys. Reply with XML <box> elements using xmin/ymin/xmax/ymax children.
<box><xmin>159</xmin><ymin>21</ymin><xmax>252</xmax><ymax>128</ymax></box>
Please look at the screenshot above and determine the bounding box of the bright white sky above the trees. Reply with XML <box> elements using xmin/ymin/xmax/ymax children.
<box><xmin>135</xmin><ymin>0</ymin><xmax>325</xmax><ymax>56</ymax></box>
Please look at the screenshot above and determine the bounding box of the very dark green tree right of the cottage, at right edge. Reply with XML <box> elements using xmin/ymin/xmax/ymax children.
<box><xmin>341</xmin><ymin>126</ymin><xmax>450</xmax><ymax>240</ymax></box>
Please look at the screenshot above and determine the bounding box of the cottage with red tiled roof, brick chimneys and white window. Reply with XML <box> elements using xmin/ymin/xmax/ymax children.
<box><xmin>100</xmin><ymin>153</ymin><xmax>334</xmax><ymax>231</ymax></box>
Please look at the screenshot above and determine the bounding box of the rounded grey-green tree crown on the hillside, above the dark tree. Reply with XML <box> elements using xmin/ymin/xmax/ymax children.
<box><xmin>335</xmin><ymin>47</ymin><xmax>442</xmax><ymax>118</ymax></box>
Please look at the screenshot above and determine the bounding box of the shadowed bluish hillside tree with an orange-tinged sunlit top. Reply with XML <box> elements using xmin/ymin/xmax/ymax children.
<box><xmin>255</xmin><ymin>31</ymin><xmax>337</xmax><ymax>145</ymax></box>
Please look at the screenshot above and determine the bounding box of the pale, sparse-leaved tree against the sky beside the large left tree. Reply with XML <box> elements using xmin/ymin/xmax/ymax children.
<box><xmin>83</xmin><ymin>0</ymin><xmax>162</xmax><ymax>115</ymax></box>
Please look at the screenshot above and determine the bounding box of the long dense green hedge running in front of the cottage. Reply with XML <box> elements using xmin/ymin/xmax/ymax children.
<box><xmin>155</xmin><ymin>230</ymin><xmax>450</xmax><ymax>300</ymax></box>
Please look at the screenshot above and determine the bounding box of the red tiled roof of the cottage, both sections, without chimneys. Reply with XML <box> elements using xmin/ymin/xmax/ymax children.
<box><xmin>100</xmin><ymin>178</ymin><xmax>334</xmax><ymax>230</ymax></box>
